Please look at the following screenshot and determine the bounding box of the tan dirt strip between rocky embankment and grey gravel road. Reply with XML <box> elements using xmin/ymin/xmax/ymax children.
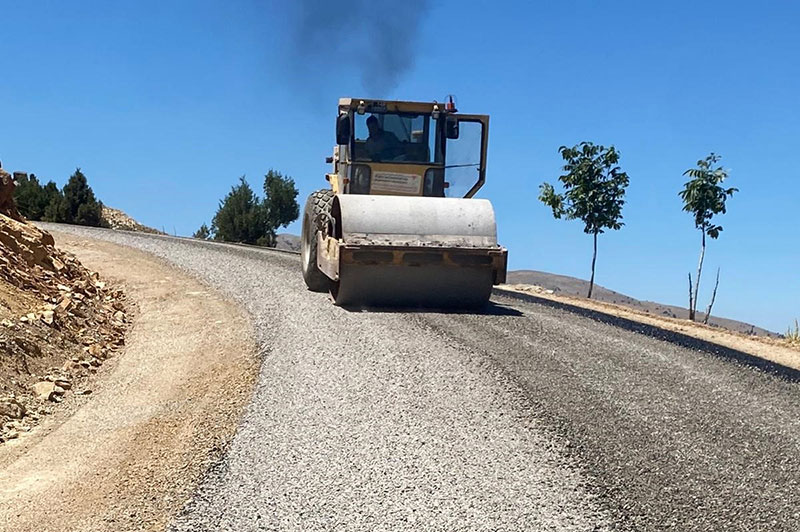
<box><xmin>0</xmin><ymin>233</ymin><xmax>257</xmax><ymax>532</ymax></box>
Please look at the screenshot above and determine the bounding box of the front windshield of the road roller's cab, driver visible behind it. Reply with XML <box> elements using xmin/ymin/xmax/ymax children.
<box><xmin>354</xmin><ymin>113</ymin><xmax>444</xmax><ymax>164</ymax></box>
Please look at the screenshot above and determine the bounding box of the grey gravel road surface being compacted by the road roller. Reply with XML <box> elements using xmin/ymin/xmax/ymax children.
<box><xmin>40</xmin><ymin>226</ymin><xmax>800</xmax><ymax>531</ymax></box>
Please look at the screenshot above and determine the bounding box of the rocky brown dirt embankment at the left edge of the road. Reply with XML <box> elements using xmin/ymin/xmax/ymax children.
<box><xmin>0</xmin><ymin>211</ymin><xmax>128</xmax><ymax>444</ymax></box>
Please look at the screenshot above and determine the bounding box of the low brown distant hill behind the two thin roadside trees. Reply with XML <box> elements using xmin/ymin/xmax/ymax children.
<box><xmin>506</xmin><ymin>270</ymin><xmax>778</xmax><ymax>337</ymax></box>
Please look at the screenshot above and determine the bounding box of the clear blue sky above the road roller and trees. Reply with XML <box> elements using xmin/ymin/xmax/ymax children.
<box><xmin>0</xmin><ymin>0</ymin><xmax>800</xmax><ymax>332</ymax></box>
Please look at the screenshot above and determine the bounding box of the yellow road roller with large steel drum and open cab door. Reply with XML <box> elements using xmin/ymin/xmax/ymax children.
<box><xmin>301</xmin><ymin>97</ymin><xmax>508</xmax><ymax>309</ymax></box>
